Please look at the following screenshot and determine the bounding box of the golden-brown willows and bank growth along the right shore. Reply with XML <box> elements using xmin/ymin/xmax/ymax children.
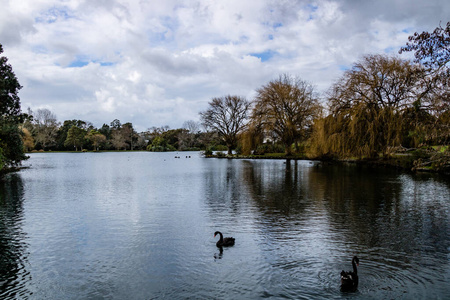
<box><xmin>202</xmin><ymin>22</ymin><xmax>450</xmax><ymax>171</ymax></box>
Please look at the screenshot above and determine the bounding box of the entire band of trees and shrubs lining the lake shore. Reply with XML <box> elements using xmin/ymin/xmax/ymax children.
<box><xmin>0</xmin><ymin>22</ymin><xmax>450</xmax><ymax>170</ymax></box>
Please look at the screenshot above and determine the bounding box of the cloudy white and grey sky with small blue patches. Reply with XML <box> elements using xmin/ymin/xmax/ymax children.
<box><xmin>0</xmin><ymin>0</ymin><xmax>450</xmax><ymax>132</ymax></box>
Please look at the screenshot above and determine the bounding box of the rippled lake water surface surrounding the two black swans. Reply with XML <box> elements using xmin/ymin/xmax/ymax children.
<box><xmin>0</xmin><ymin>152</ymin><xmax>450</xmax><ymax>299</ymax></box>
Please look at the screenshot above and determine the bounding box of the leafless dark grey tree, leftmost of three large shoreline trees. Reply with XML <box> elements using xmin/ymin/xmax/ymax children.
<box><xmin>200</xmin><ymin>95</ymin><xmax>250</xmax><ymax>155</ymax></box>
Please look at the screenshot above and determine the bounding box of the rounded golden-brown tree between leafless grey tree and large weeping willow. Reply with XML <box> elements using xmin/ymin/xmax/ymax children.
<box><xmin>252</xmin><ymin>74</ymin><xmax>321</xmax><ymax>155</ymax></box>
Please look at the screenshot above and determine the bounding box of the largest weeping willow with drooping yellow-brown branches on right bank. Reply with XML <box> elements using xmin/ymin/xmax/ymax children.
<box><xmin>311</xmin><ymin>55</ymin><xmax>426</xmax><ymax>158</ymax></box>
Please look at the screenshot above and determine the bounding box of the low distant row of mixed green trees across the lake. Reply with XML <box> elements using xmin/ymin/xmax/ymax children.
<box><xmin>21</xmin><ymin>115</ymin><xmax>224</xmax><ymax>152</ymax></box>
